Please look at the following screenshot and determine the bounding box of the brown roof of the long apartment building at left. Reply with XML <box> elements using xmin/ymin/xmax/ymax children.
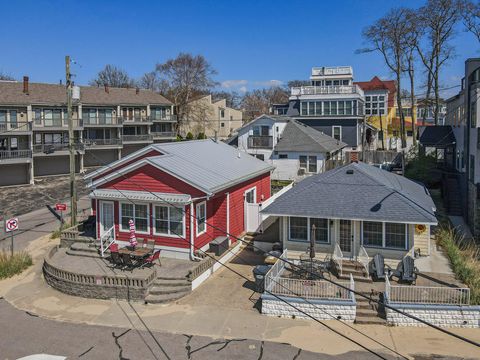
<box><xmin>0</xmin><ymin>81</ymin><xmax>172</xmax><ymax>105</ymax></box>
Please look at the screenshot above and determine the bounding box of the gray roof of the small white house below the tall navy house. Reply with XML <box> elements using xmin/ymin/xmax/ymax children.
<box><xmin>275</xmin><ymin>120</ymin><xmax>347</xmax><ymax>153</ymax></box>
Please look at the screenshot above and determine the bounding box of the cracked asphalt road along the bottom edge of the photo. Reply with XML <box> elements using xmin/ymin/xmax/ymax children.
<box><xmin>0</xmin><ymin>299</ymin><xmax>372</xmax><ymax>360</ymax></box>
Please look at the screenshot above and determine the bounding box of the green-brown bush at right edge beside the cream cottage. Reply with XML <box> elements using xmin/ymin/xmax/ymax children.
<box><xmin>436</xmin><ymin>225</ymin><xmax>480</xmax><ymax>304</ymax></box>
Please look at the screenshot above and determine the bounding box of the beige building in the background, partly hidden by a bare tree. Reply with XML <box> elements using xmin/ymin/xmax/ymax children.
<box><xmin>181</xmin><ymin>95</ymin><xmax>243</xmax><ymax>140</ymax></box>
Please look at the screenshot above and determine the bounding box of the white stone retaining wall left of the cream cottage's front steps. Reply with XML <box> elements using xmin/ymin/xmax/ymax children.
<box><xmin>262</xmin><ymin>294</ymin><xmax>356</xmax><ymax>322</ymax></box>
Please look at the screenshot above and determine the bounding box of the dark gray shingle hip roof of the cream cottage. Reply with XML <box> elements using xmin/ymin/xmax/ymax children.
<box><xmin>262</xmin><ymin>163</ymin><xmax>437</xmax><ymax>223</ymax></box>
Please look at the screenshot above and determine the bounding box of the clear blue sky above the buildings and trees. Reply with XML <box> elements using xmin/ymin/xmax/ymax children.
<box><xmin>0</xmin><ymin>0</ymin><xmax>480</xmax><ymax>97</ymax></box>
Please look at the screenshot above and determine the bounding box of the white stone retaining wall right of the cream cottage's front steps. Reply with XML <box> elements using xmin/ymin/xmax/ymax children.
<box><xmin>385</xmin><ymin>304</ymin><xmax>480</xmax><ymax>328</ymax></box>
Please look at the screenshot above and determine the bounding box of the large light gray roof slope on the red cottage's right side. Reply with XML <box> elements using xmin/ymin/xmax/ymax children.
<box><xmin>148</xmin><ymin>139</ymin><xmax>273</xmax><ymax>193</ymax></box>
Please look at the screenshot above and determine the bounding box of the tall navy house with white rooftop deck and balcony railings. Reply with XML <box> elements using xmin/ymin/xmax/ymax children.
<box><xmin>287</xmin><ymin>66</ymin><xmax>368</xmax><ymax>150</ymax></box>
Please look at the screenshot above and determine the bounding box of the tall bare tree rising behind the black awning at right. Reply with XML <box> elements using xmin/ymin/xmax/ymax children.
<box><xmin>417</xmin><ymin>0</ymin><xmax>463</xmax><ymax>125</ymax></box>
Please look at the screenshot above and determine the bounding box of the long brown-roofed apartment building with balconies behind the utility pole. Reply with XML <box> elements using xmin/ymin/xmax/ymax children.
<box><xmin>0</xmin><ymin>77</ymin><xmax>176</xmax><ymax>186</ymax></box>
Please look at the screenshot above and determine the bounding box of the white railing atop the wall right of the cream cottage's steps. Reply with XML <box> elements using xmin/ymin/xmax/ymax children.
<box><xmin>385</xmin><ymin>279</ymin><xmax>470</xmax><ymax>305</ymax></box>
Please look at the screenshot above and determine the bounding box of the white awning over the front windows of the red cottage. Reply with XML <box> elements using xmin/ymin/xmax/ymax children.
<box><xmin>89</xmin><ymin>189</ymin><xmax>192</xmax><ymax>205</ymax></box>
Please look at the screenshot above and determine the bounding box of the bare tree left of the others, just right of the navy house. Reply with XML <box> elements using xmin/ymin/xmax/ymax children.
<box><xmin>357</xmin><ymin>8</ymin><xmax>411</xmax><ymax>148</ymax></box>
